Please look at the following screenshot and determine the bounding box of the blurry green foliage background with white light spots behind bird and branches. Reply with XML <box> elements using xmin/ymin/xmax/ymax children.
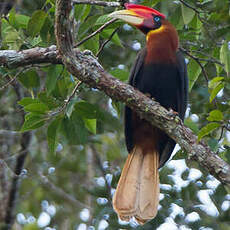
<box><xmin>0</xmin><ymin>0</ymin><xmax>230</xmax><ymax>230</ymax></box>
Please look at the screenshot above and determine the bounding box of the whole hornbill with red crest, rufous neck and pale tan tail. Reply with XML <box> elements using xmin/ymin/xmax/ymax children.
<box><xmin>109</xmin><ymin>4</ymin><xmax>188</xmax><ymax>224</ymax></box>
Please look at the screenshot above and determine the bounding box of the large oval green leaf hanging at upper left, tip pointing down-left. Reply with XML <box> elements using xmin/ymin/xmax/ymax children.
<box><xmin>27</xmin><ymin>10</ymin><xmax>47</xmax><ymax>37</ymax></box>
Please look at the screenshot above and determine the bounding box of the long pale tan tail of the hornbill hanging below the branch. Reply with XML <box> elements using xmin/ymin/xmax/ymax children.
<box><xmin>113</xmin><ymin>146</ymin><xmax>159</xmax><ymax>224</ymax></box>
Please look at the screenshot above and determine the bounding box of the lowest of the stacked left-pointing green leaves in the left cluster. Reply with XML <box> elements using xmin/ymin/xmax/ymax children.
<box><xmin>20</xmin><ymin>113</ymin><xmax>47</xmax><ymax>132</ymax></box>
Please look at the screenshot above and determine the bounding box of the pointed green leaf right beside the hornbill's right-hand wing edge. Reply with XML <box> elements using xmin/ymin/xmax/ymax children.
<box><xmin>188</xmin><ymin>59</ymin><xmax>201</xmax><ymax>91</ymax></box>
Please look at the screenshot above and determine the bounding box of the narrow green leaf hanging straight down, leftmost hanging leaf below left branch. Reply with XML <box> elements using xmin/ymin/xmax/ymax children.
<box><xmin>47</xmin><ymin>117</ymin><xmax>63</xmax><ymax>153</ymax></box>
